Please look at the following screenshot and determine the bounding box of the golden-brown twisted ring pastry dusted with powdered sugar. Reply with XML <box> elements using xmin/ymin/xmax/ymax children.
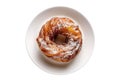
<box><xmin>36</xmin><ymin>17</ymin><xmax>82</xmax><ymax>63</ymax></box>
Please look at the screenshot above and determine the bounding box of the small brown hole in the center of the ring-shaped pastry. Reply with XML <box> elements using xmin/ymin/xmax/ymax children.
<box><xmin>54</xmin><ymin>34</ymin><xmax>67</xmax><ymax>44</ymax></box>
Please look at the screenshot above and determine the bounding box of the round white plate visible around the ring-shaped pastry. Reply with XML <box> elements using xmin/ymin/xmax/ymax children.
<box><xmin>26</xmin><ymin>7</ymin><xmax>94</xmax><ymax>74</ymax></box>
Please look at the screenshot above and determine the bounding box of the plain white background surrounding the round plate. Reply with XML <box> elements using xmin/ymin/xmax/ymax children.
<box><xmin>0</xmin><ymin>0</ymin><xmax>120</xmax><ymax>80</ymax></box>
